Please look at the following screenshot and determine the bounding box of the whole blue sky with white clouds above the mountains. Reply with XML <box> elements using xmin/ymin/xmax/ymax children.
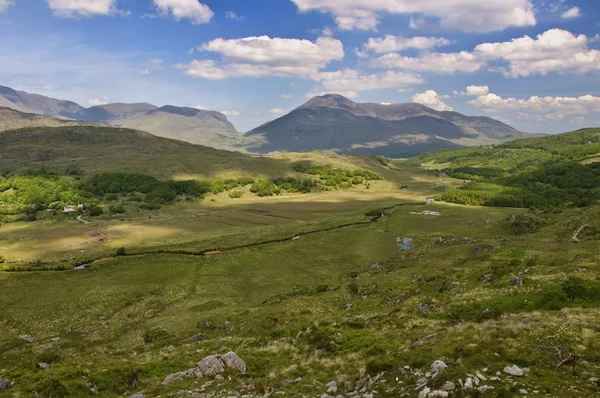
<box><xmin>0</xmin><ymin>0</ymin><xmax>600</xmax><ymax>133</ymax></box>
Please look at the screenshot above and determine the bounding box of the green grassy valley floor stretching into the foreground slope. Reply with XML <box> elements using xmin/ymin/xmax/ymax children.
<box><xmin>0</xmin><ymin>126</ymin><xmax>600</xmax><ymax>398</ymax></box>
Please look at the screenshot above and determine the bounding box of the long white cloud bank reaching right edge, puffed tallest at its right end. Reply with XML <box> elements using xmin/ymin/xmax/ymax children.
<box><xmin>371</xmin><ymin>29</ymin><xmax>600</xmax><ymax>78</ymax></box>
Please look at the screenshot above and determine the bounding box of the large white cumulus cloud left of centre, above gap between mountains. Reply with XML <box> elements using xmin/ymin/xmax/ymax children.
<box><xmin>177</xmin><ymin>36</ymin><xmax>344</xmax><ymax>80</ymax></box>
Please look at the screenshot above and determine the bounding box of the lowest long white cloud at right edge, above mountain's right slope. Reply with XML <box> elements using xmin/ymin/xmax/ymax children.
<box><xmin>469</xmin><ymin>93</ymin><xmax>600</xmax><ymax>120</ymax></box>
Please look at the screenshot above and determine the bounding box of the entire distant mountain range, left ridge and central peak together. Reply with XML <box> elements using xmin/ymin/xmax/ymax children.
<box><xmin>0</xmin><ymin>86</ymin><xmax>526</xmax><ymax>157</ymax></box>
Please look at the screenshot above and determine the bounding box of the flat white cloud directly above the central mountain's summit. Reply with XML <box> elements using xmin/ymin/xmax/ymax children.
<box><xmin>313</xmin><ymin>69</ymin><xmax>425</xmax><ymax>92</ymax></box>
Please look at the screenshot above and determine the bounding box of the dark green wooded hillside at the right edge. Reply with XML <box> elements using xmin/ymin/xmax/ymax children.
<box><xmin>404</xmin><ymin>129</ymin><xmax>600</xmax><ymax>208</ymax></box>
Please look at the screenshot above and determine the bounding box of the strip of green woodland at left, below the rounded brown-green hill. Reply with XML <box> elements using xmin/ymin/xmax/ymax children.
<box><xmin>0</xmin><ymin>166</ymin><xmax>380</xmax><ymax>222</ymax></box>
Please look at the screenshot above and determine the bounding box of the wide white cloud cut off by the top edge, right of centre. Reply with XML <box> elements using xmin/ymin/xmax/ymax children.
<box><xmin>291</xmin><ymin>0</ymin><xmax>536</xmax><ymax>32</ymax></box>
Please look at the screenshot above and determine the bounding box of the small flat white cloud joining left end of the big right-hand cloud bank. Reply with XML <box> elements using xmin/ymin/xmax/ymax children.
<box><xmin>372</xmin><ymin>51</ymin><xmax>486</xmax><ymax>74</ymax></box>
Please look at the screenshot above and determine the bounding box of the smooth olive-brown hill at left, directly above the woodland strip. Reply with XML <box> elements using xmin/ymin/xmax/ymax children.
<box><xmin>0</xmin><ymin>126</ymin><xmax>290</xmax><ymax>177</ymax></box>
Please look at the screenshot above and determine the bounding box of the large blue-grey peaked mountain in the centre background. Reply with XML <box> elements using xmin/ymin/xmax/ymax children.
<box><xmin>247</xmin><ymin>94</ymin><xmax>525</xmax><ymax>157</ymax></box>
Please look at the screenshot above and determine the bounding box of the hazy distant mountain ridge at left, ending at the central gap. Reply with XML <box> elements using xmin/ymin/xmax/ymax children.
<box><xmin>0</xmin><ymin>86</ymin><xmax>240</xmax><ymax>149</ymax></box>
